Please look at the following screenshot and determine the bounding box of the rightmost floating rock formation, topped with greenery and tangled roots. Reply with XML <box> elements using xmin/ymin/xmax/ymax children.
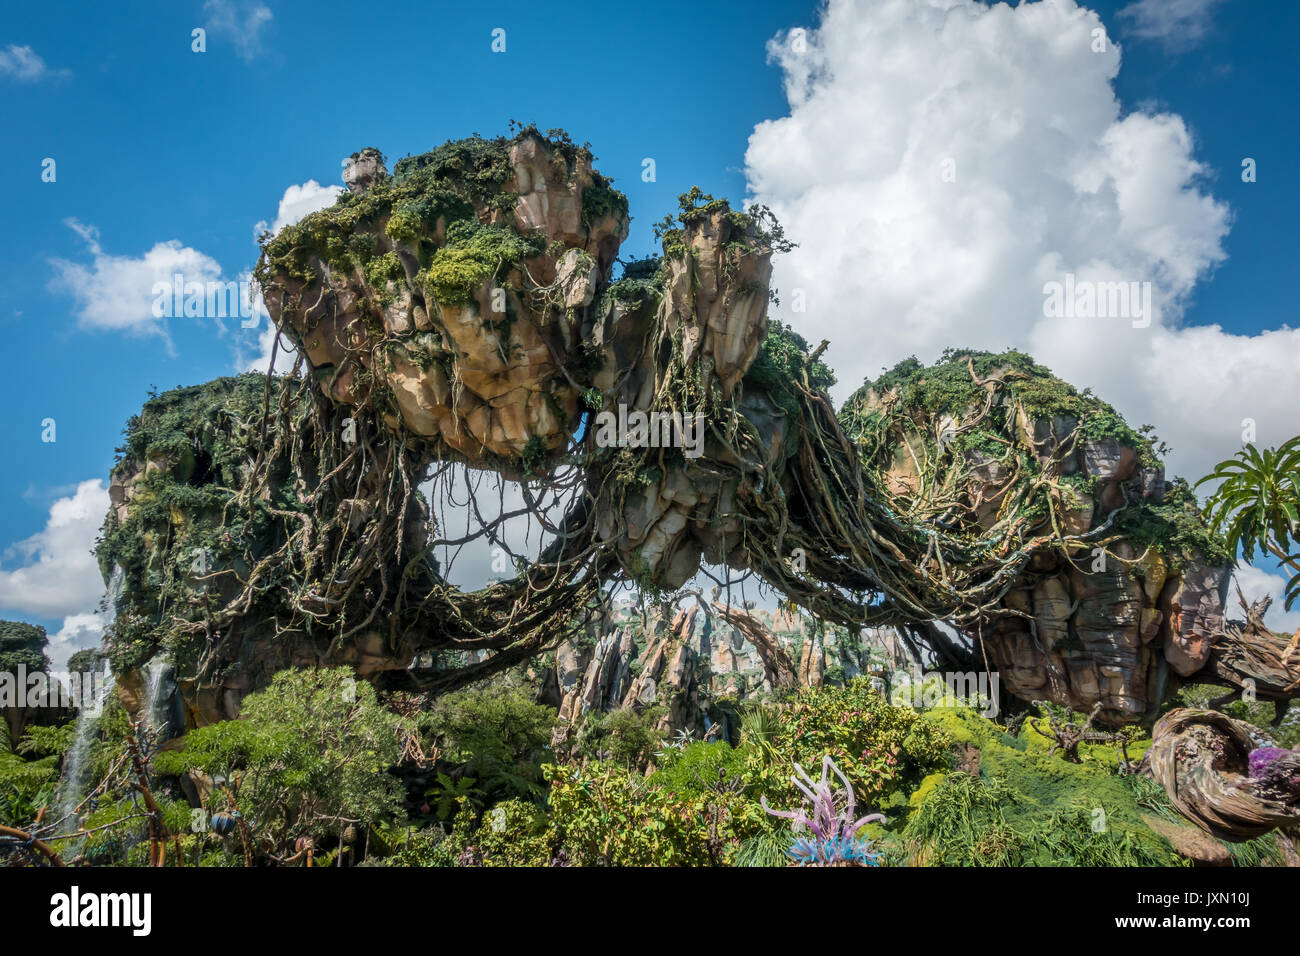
<box><xmin>842</xmin><ymin>352</ymin><xmax>1300</xmax><ymax>723</ymax></box>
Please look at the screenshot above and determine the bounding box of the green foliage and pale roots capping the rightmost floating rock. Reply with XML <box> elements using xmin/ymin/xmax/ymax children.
<box><xmin>839</xmin><ymin>349</ymin><xmax>1230</xmax><ymax>570</ymax></box>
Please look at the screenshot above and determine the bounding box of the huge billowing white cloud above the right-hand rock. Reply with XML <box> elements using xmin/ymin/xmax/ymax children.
<box><xmin>746</xmin><ymin>0</ymin><xmax>1300</xmax><ymax>477</ymax></box>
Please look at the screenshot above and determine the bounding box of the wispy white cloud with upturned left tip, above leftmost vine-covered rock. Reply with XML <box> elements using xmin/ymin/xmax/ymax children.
<box><xmin>49</xmin><ymin>219</ymin><xmax>221</xmax><ymax>336</ymax></box>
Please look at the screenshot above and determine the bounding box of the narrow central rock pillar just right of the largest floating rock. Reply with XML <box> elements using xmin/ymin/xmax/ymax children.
<box><xmin>598</xmin><ymin>206</ymin><xmax>793</xmax><ymax>589</ymax></box>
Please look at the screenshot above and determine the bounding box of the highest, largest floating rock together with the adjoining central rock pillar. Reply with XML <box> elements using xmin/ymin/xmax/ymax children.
<box><xmin>259</xmin><ymin>133</ymin><xmax>790</xmax><ymax>588</ymax></box>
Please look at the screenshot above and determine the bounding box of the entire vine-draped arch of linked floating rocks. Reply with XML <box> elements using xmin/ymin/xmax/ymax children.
<box><xmin>100</xmin><ymin>130</ymin><xmax>1300</xmax><ymax>723</ymax></box>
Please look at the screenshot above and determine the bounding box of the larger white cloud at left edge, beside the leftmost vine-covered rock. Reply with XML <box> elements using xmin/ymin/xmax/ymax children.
<box><xmin>0</xmin><ymin>479</ymin><xmax>108</xmax><ymax>618</ymax></box>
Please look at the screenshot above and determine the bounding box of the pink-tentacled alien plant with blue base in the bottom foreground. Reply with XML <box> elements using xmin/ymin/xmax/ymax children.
<box><xmin>759</xmin><ymin>754</ymin><xmax>884</xmax><ymax>866</ymax></box>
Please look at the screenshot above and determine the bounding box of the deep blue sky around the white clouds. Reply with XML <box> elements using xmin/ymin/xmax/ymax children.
<box><xmin>0</xmin><ymin>0</ymin><xmax>1300</xmax><ymax>658</ymax></box>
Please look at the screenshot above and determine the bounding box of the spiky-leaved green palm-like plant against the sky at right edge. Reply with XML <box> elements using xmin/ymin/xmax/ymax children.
<box><xmin>1196</xmin><ymin>436</ymin><xmax>1300</xmax><ymax>610</ymax></box>
